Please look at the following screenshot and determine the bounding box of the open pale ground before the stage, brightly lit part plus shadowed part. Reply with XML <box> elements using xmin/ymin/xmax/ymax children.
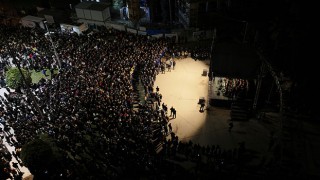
<box><xmin>155</xmin><ymin>58</ymin><xmax>279</xmax><ymax>155</ymax></box>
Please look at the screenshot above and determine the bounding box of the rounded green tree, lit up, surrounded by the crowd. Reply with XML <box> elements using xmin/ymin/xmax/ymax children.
<box><xmin>6</xmin><ymin>67</ymin><xmax>32</xmax><ymax>89</ymax></box>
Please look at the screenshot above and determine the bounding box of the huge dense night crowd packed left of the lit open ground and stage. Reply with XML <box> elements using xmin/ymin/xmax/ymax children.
<box><xmin>0</xmin><ymin>26</ymin><xmax>242</xmax><ymax>179</ymax></box>
